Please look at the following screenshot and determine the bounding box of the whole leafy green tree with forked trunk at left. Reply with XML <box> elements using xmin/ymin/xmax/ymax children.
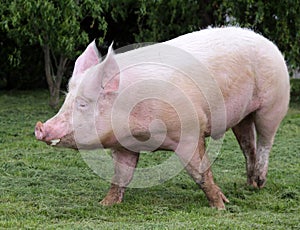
<box><xmin>1</xmin><ymin>0</ymin><xmax>108</xmax><ymax>108</ymax></box>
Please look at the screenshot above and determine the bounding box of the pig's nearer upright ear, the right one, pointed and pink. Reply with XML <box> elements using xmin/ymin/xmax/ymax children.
<box><xmin>101</xmin><ymin>43</ymin><xmax>120</xmax><ymax>92</ymax></box>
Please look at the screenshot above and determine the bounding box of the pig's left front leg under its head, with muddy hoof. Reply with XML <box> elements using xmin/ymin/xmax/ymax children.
<box><xmin>100</xmin><ymin>149</ymin><xmax>139</xmax><ymax>206</ymax></box>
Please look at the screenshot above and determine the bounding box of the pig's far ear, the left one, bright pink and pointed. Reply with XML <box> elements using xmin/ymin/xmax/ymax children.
<box><xmin>73</xmin><ymin>40</ymin><xmax>101</xmax><ymax>76</ymax></box>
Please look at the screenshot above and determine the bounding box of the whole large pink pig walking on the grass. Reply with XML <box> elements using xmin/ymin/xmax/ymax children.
<box><xmin>35</xmin><ymin>27</ymin><xmax>290</xmax><ymax>209</ymax></box>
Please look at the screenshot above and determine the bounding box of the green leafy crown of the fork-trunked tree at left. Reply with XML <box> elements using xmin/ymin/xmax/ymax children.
<box><xmin>1</xmin><ymin>0</ymin><xmax>107</xmax><ymax>59</ymax></box>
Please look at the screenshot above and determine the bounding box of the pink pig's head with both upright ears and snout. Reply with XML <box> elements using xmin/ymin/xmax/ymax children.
<box><xmin>35</xmin><ymin>42</ymin><xmax>120</xmax><ymax>149</ymax></box>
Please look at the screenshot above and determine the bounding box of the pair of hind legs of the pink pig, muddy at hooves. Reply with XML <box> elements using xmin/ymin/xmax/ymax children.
<box><xmin>232</xmin><ymin>108</ymin><xmax>285</xmax><ymax>188</ymax></box>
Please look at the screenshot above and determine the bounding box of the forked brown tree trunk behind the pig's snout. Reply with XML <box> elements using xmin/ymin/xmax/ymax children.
<box><xmin>43</xmin><ymin>45</ymin><xmax>68</xmax><ymax>109</ymax></box>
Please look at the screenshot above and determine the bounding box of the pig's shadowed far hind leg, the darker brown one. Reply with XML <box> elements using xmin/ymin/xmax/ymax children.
<box><xmin>232</xmin><ymin>114</ymin><xmax>256</xmax><ymax>185</ymax></box>
